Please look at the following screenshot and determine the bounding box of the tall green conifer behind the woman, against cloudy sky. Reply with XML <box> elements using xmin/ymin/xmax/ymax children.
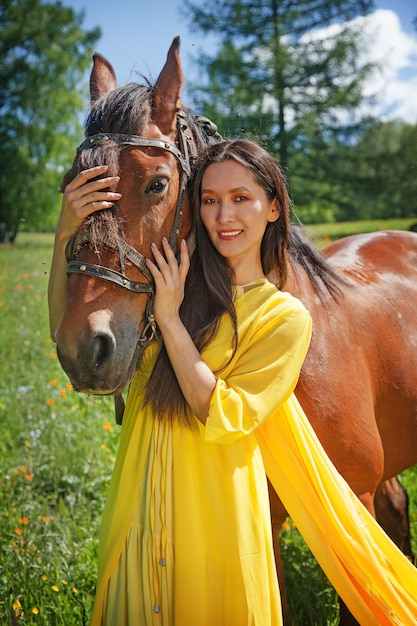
<box><xmin>183</xmin><ymin>0</ymin><xmax>375</xmax><ymax>219</ymax></box>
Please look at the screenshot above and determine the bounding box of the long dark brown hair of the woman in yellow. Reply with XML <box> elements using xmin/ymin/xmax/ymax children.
<box><xmin>144</xmin><ymin>139</ymin><xmax>290</xmax><ymax>423</ymax></box>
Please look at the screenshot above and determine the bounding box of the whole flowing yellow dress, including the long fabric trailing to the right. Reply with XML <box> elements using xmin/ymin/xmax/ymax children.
<box><xmin>92</xmin><ymin>283</ymin><xmax>417</xmax><ymax>626</ymax></box>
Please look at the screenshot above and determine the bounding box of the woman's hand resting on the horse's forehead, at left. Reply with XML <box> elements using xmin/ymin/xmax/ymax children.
<box><xmin>57</xmin><ymin>165</ymin><xmax>122</xmax><ymax>241</ymax></box>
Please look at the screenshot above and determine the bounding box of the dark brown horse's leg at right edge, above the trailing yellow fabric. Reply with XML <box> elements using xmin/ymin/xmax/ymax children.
<box><xmin>375</xmin><ymin>476</ymin><xmax>413</xmax><ymax>560</ymax></box>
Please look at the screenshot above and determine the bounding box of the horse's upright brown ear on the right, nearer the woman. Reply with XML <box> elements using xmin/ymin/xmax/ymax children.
<box><xmin>152</xmin><ymin>37</ymin><xmax>184</xmax><ymax>135</ymax></box>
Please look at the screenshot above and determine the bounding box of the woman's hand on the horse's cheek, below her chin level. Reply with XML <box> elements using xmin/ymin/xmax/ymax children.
<box><xmin>146</xmin><ymin>237</ymin><xmax>190</xmax><ymax>332</ymax></box>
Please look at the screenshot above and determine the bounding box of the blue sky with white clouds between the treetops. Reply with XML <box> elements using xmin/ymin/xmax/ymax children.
<box><xmin>63</xmin><ymin>0</ymin><xmax>417</xmax><ymax>123</ymax></box>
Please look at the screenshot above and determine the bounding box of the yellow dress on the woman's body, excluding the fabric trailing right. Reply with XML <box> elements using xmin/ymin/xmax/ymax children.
<box><xmin>92</xmin><ymin>283</ymin><xmax>311</xmax><ymax>626</ymax></box>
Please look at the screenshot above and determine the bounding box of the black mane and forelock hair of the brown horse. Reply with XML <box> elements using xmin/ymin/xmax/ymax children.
<box><xmin>66</xmin><ymin>79</ymin><xmax>345</xmax><ymax>298</ymax></box>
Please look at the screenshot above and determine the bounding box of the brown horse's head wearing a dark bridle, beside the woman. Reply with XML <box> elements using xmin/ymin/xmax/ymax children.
<box><xmin>56</xmin><ymin>38</ymin><xmax>214</xmax><ymax>394</ymax></box>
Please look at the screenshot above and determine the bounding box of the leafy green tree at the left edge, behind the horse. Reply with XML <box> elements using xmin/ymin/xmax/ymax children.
<box><xmin>0</xmin><ymin>0</ymin><xmax>100</xmax><ymax>241</ymax></box>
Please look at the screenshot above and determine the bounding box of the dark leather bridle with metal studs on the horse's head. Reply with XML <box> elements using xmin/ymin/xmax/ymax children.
<box><xmin>66</xmin><ymin>111</ymin><xmax>199</xmax><ymax>352</ymax></box>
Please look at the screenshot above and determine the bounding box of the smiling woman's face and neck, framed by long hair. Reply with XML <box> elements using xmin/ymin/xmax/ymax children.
<box><xmin>200</xmin><ymin>159</ymin><xmax>279</xmax><ymax>284</ymax></box>
